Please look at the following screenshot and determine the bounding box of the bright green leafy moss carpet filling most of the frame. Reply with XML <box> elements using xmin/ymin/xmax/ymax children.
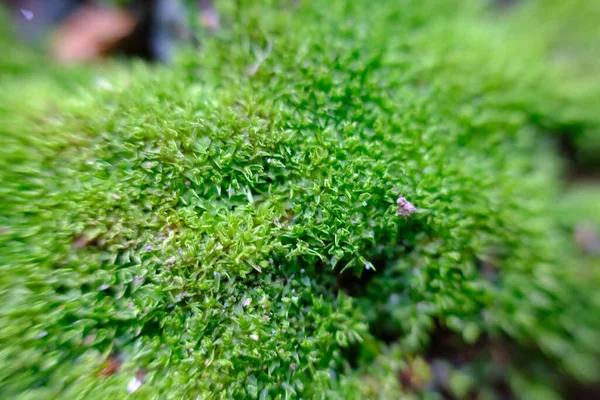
<box><xmin>0</xmin><ymin>1</ymin><xmax>600</xmax><ymax>399</ymax></box>
